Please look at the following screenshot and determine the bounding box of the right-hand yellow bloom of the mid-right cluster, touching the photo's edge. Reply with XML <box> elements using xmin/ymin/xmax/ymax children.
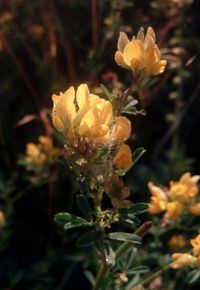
<box><xmin>168</xmin><ymin>172</ymin><xmax>200</xmax><ymax>202</ymax></box>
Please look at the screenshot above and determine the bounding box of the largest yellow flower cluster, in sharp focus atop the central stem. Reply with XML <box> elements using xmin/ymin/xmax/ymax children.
<box><xmin>52</xmin><ymin>84</ymin><xmax>132</xmax><ymax>174</ymax></box>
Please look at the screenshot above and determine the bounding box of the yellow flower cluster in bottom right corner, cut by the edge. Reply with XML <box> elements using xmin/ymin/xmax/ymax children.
<box><xmin>171</xmin><ymin>235</ymin><xmax>200</xmax><ymax>269</ymax></box>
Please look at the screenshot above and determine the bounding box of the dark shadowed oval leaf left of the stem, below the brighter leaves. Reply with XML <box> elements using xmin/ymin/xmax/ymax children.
<box><xmin>77</xmin><ymin>231</ymin><xmax>104</xmax><ymax>247</ymax></box>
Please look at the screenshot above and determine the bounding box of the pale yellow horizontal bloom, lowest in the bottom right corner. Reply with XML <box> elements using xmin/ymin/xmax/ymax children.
<box><xmin>171</xmin><ymin>253</ymin><xmax>197</xmax><ymax>269</ymax></box>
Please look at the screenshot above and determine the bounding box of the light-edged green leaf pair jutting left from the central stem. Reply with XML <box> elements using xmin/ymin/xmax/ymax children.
<box><xmin>54</xmin><ymin>212</ymin><xmax>91</xmax><ymax>230</ymax></box>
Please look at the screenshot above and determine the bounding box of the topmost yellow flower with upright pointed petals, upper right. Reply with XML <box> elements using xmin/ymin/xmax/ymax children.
<box><xmin>115</xmin><ymin>27</ymin><xmax>167</xmax><ymax>76</ymax></box>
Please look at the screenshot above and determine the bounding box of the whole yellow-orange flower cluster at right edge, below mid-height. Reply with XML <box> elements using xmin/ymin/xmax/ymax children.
<box><xmin>148</xmin><ymin>172</ymin><xmax>200</xmax><ymax>224</ymax></box>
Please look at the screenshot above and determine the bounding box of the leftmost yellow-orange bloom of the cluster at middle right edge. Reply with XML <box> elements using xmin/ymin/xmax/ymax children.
<box><xmin>148</xmin><ymin>182</ymin><xmax>167</xmax><ymax>214</ymax></box>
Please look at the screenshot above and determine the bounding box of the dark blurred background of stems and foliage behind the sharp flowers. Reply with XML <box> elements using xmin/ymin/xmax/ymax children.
<box><xmin>0</xmin><ymin>0</ymin><xmax>200</xmax><ymax>290</ymax></box>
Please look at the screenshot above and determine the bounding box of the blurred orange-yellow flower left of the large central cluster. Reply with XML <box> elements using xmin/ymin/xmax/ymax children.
<box><xmin>26</xmin><ymin>136</ymin><xmax>59</xmax><ymax>165</ymax></box>
